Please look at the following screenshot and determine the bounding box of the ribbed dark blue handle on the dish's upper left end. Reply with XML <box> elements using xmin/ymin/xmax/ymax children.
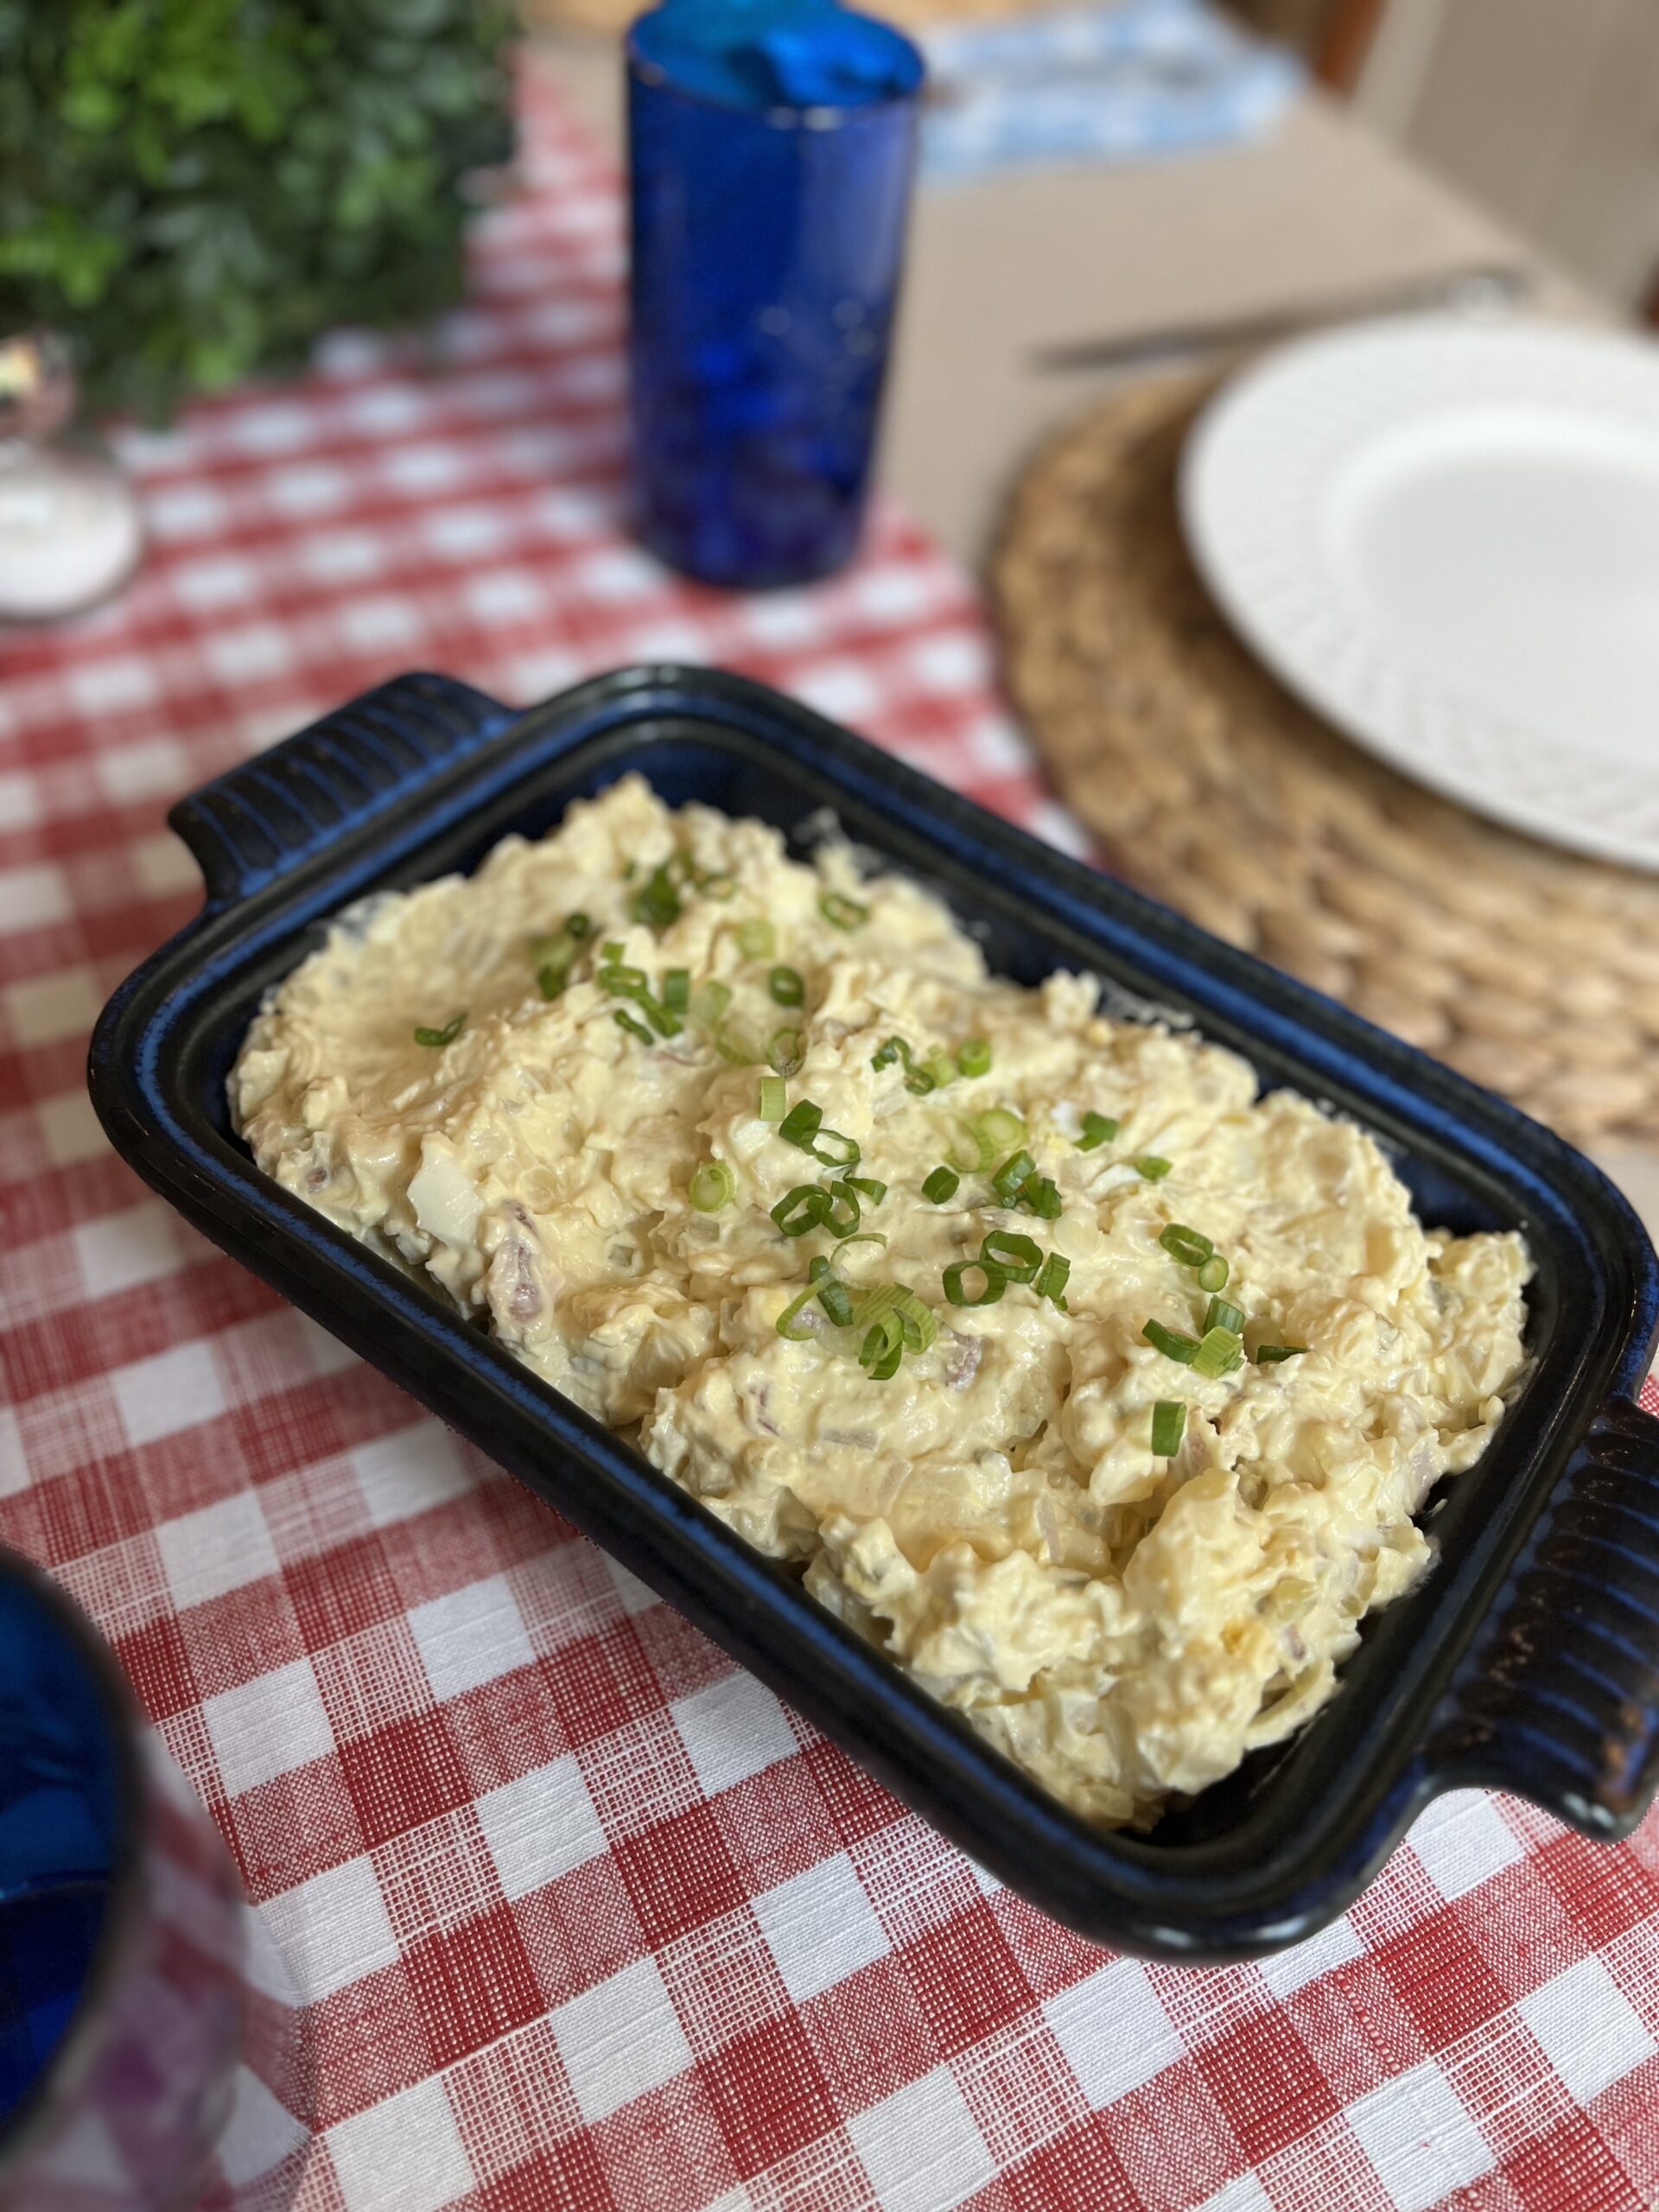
<box><xmin>168</xmin><ymin>675</ymin><xmax>515</xmax><ymax>907</ymax></box>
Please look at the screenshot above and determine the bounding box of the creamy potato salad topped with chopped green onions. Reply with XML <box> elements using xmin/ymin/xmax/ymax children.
<box><xmin>230</xmin><ymin>777</ymin><xmax>1529</xmax><ymax>1825</ymax></box>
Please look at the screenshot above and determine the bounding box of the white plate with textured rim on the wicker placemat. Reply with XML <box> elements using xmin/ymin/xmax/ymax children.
<box><xmin>1181</xmin><ymin>316</ymin><xmax>1659</xmax><ymax>869</ymax></box>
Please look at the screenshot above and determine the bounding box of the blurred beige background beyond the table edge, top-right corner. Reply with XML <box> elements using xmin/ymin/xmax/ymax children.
<box><xmin>1356</xmin><ymin>0</ymin><xmax>1659</xmax><ymax>305</ymax></box>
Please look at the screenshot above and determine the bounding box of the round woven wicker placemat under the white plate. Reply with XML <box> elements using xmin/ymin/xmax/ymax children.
<box><xmin>993</xmin><ymin>376</ymin><xmax>1659</xmax><ymax>1141</ymax></box>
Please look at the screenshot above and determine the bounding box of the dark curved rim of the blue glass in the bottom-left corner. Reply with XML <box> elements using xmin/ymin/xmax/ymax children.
<box><xmin>0</xmin><ymin>1544</ymin><xmax>149</xmax><ymax>2199</ymax></box>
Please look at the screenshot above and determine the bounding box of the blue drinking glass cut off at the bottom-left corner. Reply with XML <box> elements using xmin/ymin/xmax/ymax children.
<box><xmin>0</xmin><ymin>1548</ymin><xmax>244</xmax><ymax>2212</ymax></box>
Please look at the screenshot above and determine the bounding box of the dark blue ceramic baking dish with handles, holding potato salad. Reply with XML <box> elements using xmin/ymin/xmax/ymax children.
<box><xmin>91</xmin><ymin>668</ymin><xmax>1659</xmax><ymax>1960</ymax></box>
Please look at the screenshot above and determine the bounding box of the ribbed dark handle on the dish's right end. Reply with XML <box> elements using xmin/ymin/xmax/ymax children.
<box><xmin>1429</xmin><ymin>1398</ymin><xmax>1659</xmax><ymax>1836</ymax></box>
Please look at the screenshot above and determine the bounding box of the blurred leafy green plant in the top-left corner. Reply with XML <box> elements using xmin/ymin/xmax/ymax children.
<box><xmin>0</xmin><ymin>0</ymin><xmax>511</xmax><ymax>418</ymax></box>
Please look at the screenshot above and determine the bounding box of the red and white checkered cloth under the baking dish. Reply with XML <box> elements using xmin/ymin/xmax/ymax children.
<box><xmin>0</xmin><ymin>60</ymin><xmax>1659</xmax><ymax>2212</ymax></box>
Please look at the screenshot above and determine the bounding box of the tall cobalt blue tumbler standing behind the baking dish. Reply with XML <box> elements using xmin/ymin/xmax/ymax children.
<box><xmin>628</xmin><ymin>0</ymin><xmax>923</xmax><ymax>588</ymax></box>
